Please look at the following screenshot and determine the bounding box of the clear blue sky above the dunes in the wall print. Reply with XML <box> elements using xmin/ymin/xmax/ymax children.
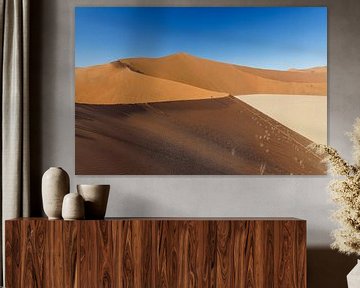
<box><xmin>75</xmin><ymin>7</ymin><xmax>327</xmax><ymax>70</ymax></box>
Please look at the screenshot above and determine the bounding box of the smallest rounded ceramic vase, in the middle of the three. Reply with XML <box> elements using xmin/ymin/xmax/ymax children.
<box><xmin>61</xmin><ymin>192</ymin><xmax>85</xmax><ymax>220</ymax></box>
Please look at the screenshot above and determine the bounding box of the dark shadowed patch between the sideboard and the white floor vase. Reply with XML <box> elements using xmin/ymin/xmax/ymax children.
<box><xmin>307</xmin><ymin>248</ymin><xmax>356</xmax><ymax>288</ymax></box>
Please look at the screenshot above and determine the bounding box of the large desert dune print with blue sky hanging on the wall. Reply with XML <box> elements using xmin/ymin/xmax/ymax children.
<box><xmin>75</xmin><ymin>7</ymin><xmax>327</xmax><ymax>175</ymax></box>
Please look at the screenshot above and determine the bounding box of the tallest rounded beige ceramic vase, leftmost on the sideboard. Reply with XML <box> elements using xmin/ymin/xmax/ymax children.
<box><xmin>41</xmin><ymin>167</ymin><xmax>70</xmax><ymax>219</ymax></box>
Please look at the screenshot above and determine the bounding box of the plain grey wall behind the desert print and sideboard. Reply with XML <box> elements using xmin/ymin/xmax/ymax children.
<box><xmin>30</xmin><ymin>0</ymin><xmax>360</xmax><ymax>247</ymax></box>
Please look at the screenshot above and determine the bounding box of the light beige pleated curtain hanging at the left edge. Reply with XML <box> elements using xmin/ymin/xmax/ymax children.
<box><xmin>0</xmin><ymin>0</ymin><xmax>29</xmax><ymax>283</ymax></box>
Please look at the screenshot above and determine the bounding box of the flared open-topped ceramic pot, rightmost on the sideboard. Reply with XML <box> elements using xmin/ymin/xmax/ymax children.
<box><xmin>77</xmin><ymin>184</ymin><xmax>110</xmax><ymax>219</ymax></box>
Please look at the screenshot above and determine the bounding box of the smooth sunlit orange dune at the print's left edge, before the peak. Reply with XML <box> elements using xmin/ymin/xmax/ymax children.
<box><xmin>75</xmin><ymin>62</ymin><xmax>228</xmax><ymax>104</ymax></box>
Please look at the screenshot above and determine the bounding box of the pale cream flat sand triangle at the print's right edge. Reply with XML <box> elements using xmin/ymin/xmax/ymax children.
<box><xmin>238</xmin><ymin>94</ymin><xmax>327</xmax><ymax>144</ymax></box>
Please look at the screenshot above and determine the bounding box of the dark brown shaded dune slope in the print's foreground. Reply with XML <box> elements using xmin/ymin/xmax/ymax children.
<box><xmin>75</xmin><ymin>97</ymin><xmax>326</xmax><ymax>175</ymax></box>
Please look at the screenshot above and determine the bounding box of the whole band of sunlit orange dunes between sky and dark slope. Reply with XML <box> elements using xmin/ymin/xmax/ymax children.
<box><xmin>75</xmin><ymin>53</ymin><xmax>327</xmax><ymax>104</ymax></box>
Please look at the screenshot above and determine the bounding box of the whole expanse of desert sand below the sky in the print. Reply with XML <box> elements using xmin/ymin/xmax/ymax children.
<box><xmin>75</xmin><ymin>53</ymin><xmax>327</xmax><ymax>175</ymax></box>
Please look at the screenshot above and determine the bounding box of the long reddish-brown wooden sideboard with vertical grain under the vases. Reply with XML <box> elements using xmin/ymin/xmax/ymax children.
<box><xmin>5</xmin><ymin>218</ymin><xmax>306</xmax><ymax>288</ymax></box>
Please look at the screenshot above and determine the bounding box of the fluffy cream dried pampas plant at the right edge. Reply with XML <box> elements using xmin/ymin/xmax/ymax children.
<box><xmin>311</xmin><ymin>118</ymin><xmax>360</xmax><ymax>255</ymax></box>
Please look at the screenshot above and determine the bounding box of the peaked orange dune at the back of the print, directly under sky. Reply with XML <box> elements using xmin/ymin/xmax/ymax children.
<box><xmin>121</xmin><ymin>53</ymin><xmax>327</xmax><ymax>95</ymax></box>
